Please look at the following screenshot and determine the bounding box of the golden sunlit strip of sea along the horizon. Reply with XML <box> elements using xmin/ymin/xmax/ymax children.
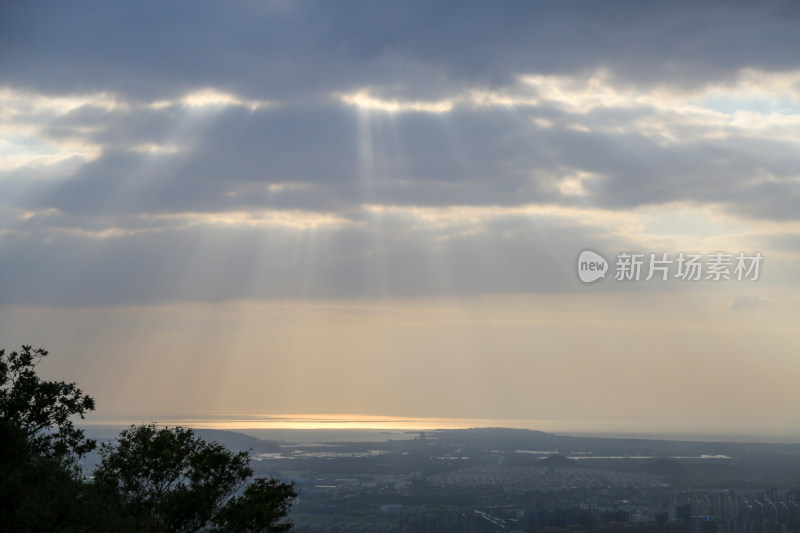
<box><xmin>80</xmin><ymin>413</ymin><xmax>800</xmax><ymax>443</ymax></box>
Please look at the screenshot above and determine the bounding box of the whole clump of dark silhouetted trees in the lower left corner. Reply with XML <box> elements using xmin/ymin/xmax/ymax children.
<box><xmin>0</xmin><ymin>346</ymin><xmax>296</xmax><ymax>532</ymax></box>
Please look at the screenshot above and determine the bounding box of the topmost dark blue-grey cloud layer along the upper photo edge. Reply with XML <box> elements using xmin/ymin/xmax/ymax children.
<box><xmin>0</xmin><ymin>1</ymin><xmax>800</xmax><ymax>99</ymax></box>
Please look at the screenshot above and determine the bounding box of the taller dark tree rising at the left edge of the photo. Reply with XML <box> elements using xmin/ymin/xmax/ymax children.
<box><xmin>0</xmin><ymin>346</ymin><xmax>95</xmax><ymax>531</ymax></box>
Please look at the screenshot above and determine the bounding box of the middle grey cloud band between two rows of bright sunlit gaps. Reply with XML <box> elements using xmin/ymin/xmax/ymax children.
<box><xmin>6</xmin><ymin>101</ymin><xmax>800</xmax><ymax>220</ymax></box>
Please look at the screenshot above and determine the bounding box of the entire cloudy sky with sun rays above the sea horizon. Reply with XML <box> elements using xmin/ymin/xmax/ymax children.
<box><xmin>0</xmin><ymin>0</ymin><xmax>800</xmax><ymax>439</ymax></box>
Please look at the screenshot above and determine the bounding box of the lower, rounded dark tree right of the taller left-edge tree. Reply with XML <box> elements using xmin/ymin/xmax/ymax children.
<box><xmin>94</xmin><ymin>424</ymin><xmax>296</xmax><ymax>532</ymax></box>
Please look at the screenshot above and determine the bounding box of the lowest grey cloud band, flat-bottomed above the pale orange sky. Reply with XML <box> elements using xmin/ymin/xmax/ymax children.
<box><xmin>0</xmin><ymin>207</ymin><xmax>610</xmax><ymax>305</ymax></box>
